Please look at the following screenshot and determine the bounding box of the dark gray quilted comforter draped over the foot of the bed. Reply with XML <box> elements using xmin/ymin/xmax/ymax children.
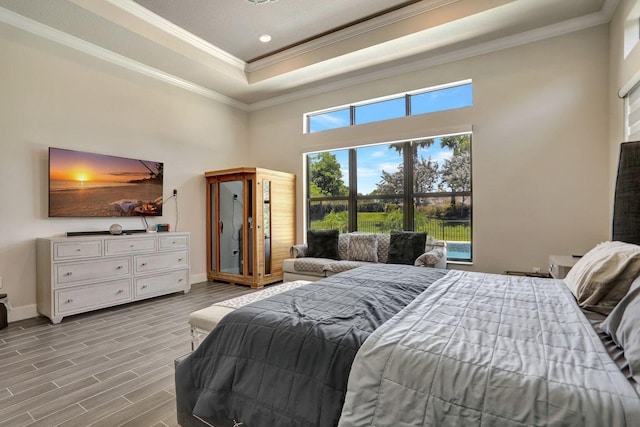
<box><xmin>176</xmin><ymin>264</ymin><xmax>446</xmax><ymax>427</ymax></box>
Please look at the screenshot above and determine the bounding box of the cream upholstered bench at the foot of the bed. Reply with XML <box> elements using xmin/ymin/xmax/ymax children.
<box><xmin>189</xmin><ymin>280</ymin><xmax>311</xmax><ymax>350</ymax></box>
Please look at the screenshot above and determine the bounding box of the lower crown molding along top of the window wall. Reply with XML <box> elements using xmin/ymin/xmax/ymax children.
<box><xmin>248</xmin><ymin>4</ymin><xmax>619</xmax><ymax>111</ymax></box>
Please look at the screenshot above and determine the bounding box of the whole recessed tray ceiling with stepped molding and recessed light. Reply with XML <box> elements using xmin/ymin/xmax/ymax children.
<box><xmin>0</xmin><ymin>0</ymin><xmax>619</xmax><ymax>110</ymax></box>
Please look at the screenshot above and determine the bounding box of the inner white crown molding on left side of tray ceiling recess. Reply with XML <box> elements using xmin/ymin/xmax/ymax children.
<box><xmin>105</xmin><ymin>0</ymin><xmax>247</xmax><ymax>71</ymax></box>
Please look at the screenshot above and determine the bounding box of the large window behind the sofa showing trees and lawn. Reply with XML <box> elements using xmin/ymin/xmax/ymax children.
<box><xmin>307</xmin><ymin>133</ymin><xmax>472</xmax><ymax>261</ymax></box>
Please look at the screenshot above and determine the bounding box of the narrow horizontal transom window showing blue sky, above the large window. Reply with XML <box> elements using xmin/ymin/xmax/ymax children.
<box><xmin>304</xmin><ymin>80</ymin><xmax>473</xmax><ymax>133</ymax></box>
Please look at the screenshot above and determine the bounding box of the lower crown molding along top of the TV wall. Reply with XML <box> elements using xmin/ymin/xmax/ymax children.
<box><xmin>0</xmin><ymin>7</ymin><xmax>249</xmax><ymax>111</ymax></box>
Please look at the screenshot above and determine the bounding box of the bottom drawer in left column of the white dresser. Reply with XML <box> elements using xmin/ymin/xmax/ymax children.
<box><xmin>55</xmin><ymin>279</ymin><xmax>132</xmax><ymax>314</ymax></box>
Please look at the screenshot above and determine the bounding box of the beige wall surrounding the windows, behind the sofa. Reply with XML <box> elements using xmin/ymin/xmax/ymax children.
<box><xmin>250</xmin><ymin>25</ymin><xmax>610</xmax><ymax>273</ymax></box>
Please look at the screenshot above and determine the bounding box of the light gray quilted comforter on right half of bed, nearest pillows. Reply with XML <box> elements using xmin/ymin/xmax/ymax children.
<box><xmin>339</xmin><ymin>271</ymin><xmax>640</xmax><ymax>427</ymax></box>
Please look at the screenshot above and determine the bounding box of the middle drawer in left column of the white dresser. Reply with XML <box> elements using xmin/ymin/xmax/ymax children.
<box><xmin>54</xmin><ymin>258</ymin><xmax>131</xmax><ymax>287</ymax></box>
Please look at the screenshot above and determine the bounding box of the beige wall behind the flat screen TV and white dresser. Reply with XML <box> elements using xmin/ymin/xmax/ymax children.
<box><xmin>0</xmin><ymin>28</ymin><xmax>248</xmax><ymax>320</ymax></box>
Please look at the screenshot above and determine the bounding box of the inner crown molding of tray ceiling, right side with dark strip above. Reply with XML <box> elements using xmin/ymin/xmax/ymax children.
<box><xmin>246</xmin><ymin>0</ymin><xmax>459</xmax><ymax>73</ymax></box>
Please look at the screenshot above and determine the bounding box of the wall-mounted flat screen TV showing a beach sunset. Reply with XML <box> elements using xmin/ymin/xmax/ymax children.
<box><xmin>49</xmin><ymin>148</ymin><xmax>164</xmax><ymax>217</ymax></box>
